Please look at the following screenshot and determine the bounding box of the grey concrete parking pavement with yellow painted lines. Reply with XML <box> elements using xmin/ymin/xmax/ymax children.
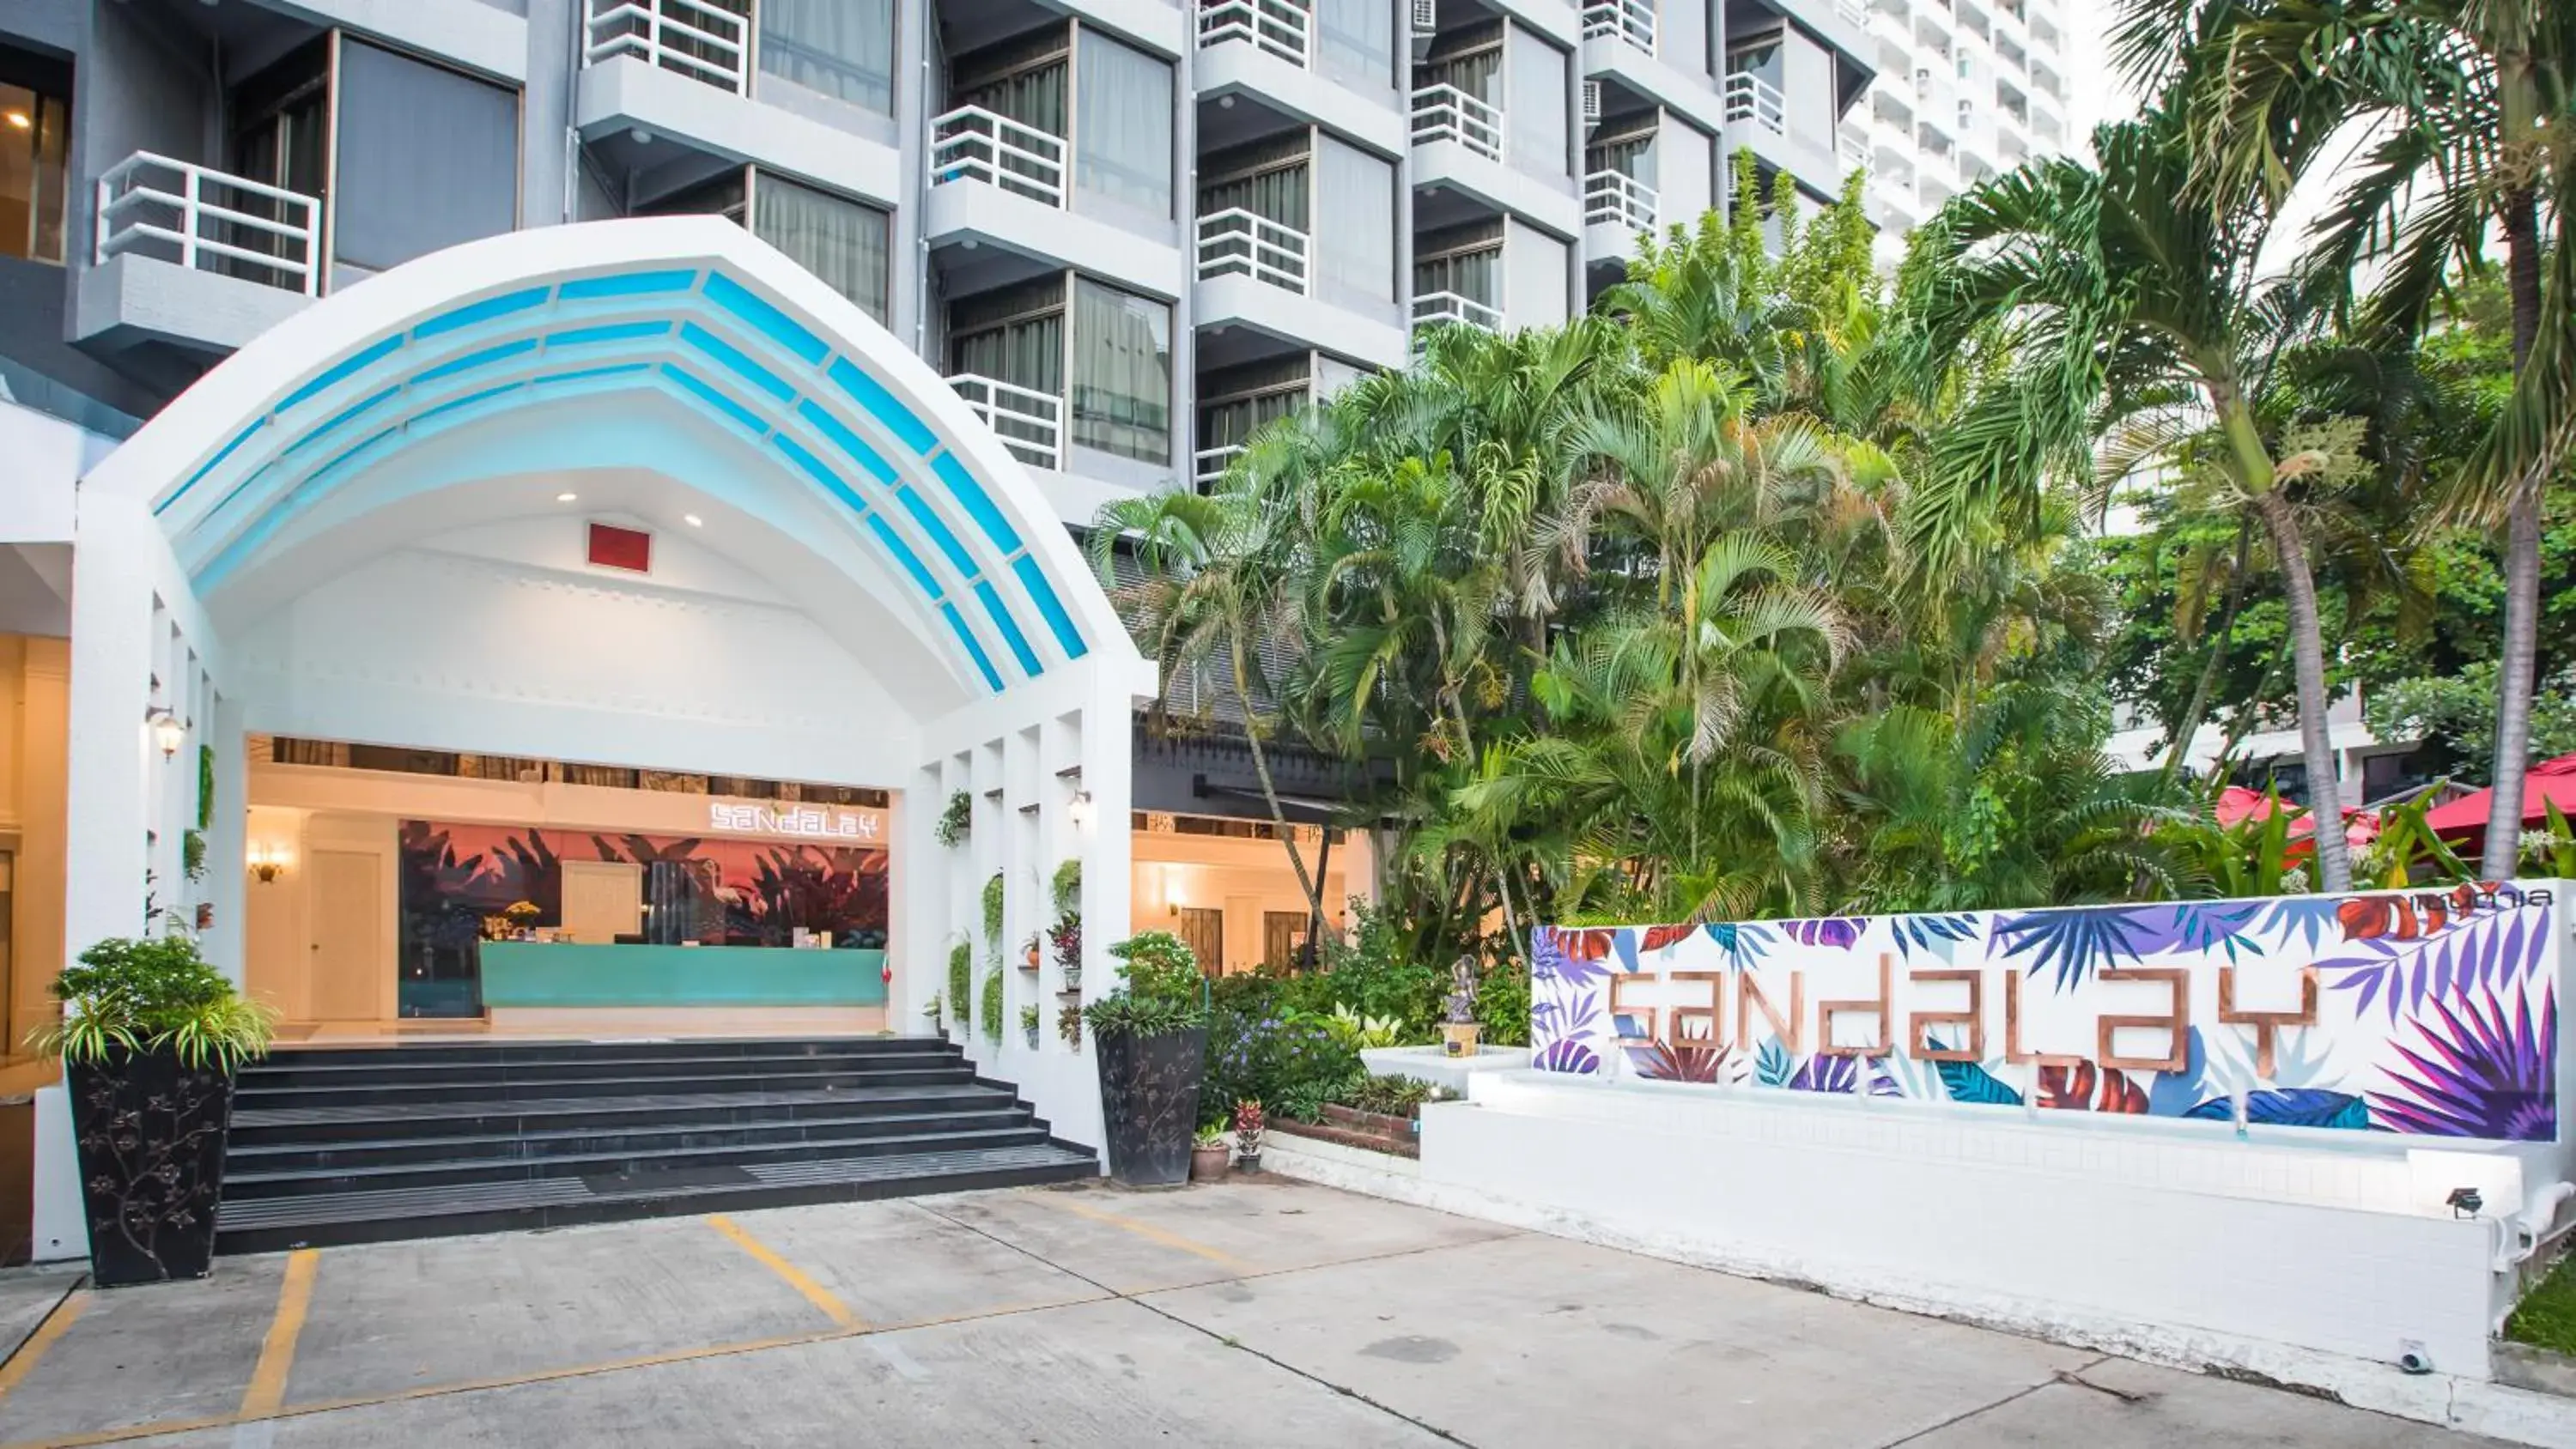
<box><xmin>0</xmin><ymin>1179</ymin><xmax>2486</xmax><ymax>1449</ymax></box>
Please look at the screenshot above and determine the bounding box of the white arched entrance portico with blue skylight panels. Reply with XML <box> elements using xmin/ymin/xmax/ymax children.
<box><xmin>41</xmin><ymin>216</ymin><xmax>1151</xmax><ymax>1261</ymax></box>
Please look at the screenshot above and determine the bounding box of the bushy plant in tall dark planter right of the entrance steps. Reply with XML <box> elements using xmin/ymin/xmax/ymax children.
<box><xmin>1082</xmin><ymin>931</ymin><xmax>1208</xmax><ymax>1186</ymax></box>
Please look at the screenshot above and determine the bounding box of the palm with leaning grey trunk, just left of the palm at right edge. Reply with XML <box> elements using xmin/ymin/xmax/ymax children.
<box><xmin>1906</xmin><ymin>108</ymin><xmax>2352</xmax><ymax>890</ymax></box>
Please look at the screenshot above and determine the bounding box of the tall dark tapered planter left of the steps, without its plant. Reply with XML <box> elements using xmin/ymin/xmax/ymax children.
<box><xmin>70</xmin><ymin>1052</ymin><xmax>232</xmax><ymax>1287</ymax></box>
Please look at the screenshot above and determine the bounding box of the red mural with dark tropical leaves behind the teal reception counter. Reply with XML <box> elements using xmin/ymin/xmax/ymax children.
<box><xmin>399</xmin><ymin>821</ymin><xmax>886</xmax><ymax>1016</ymax></box>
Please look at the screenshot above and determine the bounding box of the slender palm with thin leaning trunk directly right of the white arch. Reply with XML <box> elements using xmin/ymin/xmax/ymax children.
<box><xmin>1090</xmin><ymin>476</ymin><xmax>1324</xmax><ymax>939</ymax></box>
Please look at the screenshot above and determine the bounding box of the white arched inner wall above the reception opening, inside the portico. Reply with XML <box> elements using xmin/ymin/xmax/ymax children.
<box><xmin>232</xmin><ymin>518</ymin><xmax>912</xmax><ymax>785</ymax></box>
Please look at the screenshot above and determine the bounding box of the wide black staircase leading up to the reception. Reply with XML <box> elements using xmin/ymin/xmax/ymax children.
<box><xmin>214</xmin><ymin>1037</ymin><xmax>1100</xmax><ymax>1253</ymax></box>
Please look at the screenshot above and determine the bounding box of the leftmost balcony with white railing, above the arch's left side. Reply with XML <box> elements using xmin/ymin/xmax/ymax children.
<box><xmin>72</xmin><ymin>152</ymin><xmax>322</xmax><ymax>353</ymax></box>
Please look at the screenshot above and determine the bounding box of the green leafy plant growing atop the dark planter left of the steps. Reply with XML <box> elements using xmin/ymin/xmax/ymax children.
<box><xmin>28</xmin><ymin>931</ymin><xmax>268</xmax><ymax>1070</ymax></box>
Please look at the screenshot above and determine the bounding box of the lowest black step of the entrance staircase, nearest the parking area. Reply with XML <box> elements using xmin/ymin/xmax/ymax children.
<box><xmin>214</xmin><ymin>1143</ymin><xmax>1100</xmax><ymax>1253</ymax></box>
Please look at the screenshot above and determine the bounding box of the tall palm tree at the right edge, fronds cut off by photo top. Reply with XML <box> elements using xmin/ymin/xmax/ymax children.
<box><xmin>2117</xmin><ymin>0</ymin><xmax>2576</xmax><ymax>877</ymax></box>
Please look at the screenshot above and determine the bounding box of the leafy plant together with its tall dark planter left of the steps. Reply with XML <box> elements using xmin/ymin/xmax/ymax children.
<box><xmin>31</xmin><ymin>931</ymin><xmax>268</xmax><ymax>1287</ymax></box>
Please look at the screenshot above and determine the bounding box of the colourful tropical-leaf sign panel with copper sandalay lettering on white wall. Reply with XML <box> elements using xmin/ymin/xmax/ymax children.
<box><xmin>1530</xmin><ymin>882</ymin><xmax>2568</xmax><ymax>1143</ymax></box>
